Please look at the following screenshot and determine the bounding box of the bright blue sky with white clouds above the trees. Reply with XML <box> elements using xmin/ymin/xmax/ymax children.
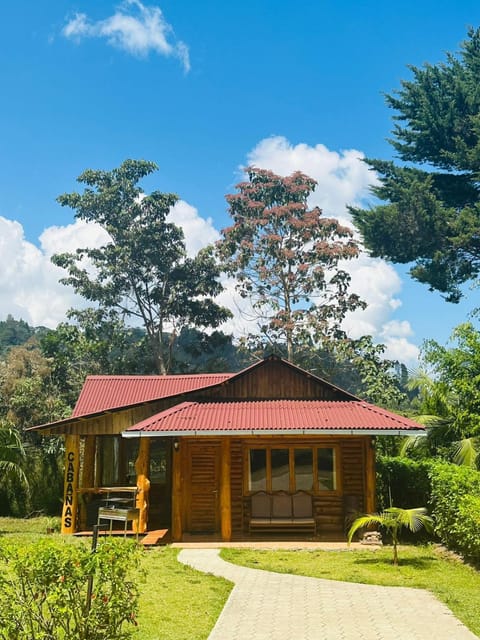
<box><xmin>0</xmin><ymin>0</ymin><xmax>480</xmax><ymax>362</ymax></box>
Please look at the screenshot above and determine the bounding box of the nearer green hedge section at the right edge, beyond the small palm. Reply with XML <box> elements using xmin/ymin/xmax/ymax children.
<box><xmin>430</xmin><ymin>463</ymin><xmax>480</xmax><ymax>562</ymax></box>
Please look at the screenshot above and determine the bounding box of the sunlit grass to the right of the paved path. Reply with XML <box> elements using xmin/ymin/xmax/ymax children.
<box><xmin>221</xmin><ymin>545</ymin><xmax>480</xmax><ymax>636</ymax></box>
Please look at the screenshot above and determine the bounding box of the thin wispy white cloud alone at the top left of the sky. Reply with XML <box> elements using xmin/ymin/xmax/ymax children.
<box><xmin>62</xmin><ymin>0</ymin><xmax>190</xmax><ymax>72</ymax></box>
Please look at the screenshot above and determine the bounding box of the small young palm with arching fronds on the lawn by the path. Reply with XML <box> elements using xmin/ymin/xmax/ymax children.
<box><xmin>348</xmin><ymin>507</ymin><xmax>433</xmax><ymax>566</ymax></box>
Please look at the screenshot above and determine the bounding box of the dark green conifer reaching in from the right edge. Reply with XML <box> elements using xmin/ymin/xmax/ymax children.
<box><xmin>352</xmin><ymin>29</ymin><xmax>480</xmax><ymax>302</ymax></box>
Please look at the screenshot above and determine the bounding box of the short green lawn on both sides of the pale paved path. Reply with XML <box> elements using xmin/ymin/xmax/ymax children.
<box><xmin>0</xmin><ymin>518</ymin><xmax>480</xmax><ymax>640</ymax></box>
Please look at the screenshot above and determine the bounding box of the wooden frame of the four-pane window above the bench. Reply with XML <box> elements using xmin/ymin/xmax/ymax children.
<box><xmin>244</xmin><ymin>442</ymin><xmax>341</xmax><ymax>496</ymax></box>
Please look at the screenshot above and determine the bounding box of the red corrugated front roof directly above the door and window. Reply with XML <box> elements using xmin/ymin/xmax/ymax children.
<box><xmin>124</xmin><ymin>400</ymin><xmax>424</xmax><ymax>437</ymax></box>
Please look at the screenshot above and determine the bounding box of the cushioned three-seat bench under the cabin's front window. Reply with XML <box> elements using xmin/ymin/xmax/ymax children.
<box><xmin>249</xmin><ymin>491</ymin><xmax>316</xmax><ymax>535</ymax></box>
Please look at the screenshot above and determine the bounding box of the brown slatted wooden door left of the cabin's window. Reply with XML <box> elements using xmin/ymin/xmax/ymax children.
<box><xmin>186</xmin><ymin>442</ymin><xmax>220</xmax><ymax>534</ymax></box>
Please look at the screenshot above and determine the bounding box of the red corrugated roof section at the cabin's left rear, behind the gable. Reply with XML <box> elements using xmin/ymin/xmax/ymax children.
<box><xmin>72</xmin><ymin>373</ymin><xmax>234</xmax><ymax>418</ymax></box>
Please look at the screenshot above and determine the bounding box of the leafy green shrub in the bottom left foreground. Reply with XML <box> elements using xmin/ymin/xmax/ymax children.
<box><xmin>0</xmin><ymin>538</ymin><xmax>139</xmax><ymax>640</ymax></box>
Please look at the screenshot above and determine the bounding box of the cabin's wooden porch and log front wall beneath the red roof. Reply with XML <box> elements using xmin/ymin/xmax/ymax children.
<box><xmin>62</xmin><ymin>435</ymin><xmax>375</xmax><ymax>542</ymax></box>
